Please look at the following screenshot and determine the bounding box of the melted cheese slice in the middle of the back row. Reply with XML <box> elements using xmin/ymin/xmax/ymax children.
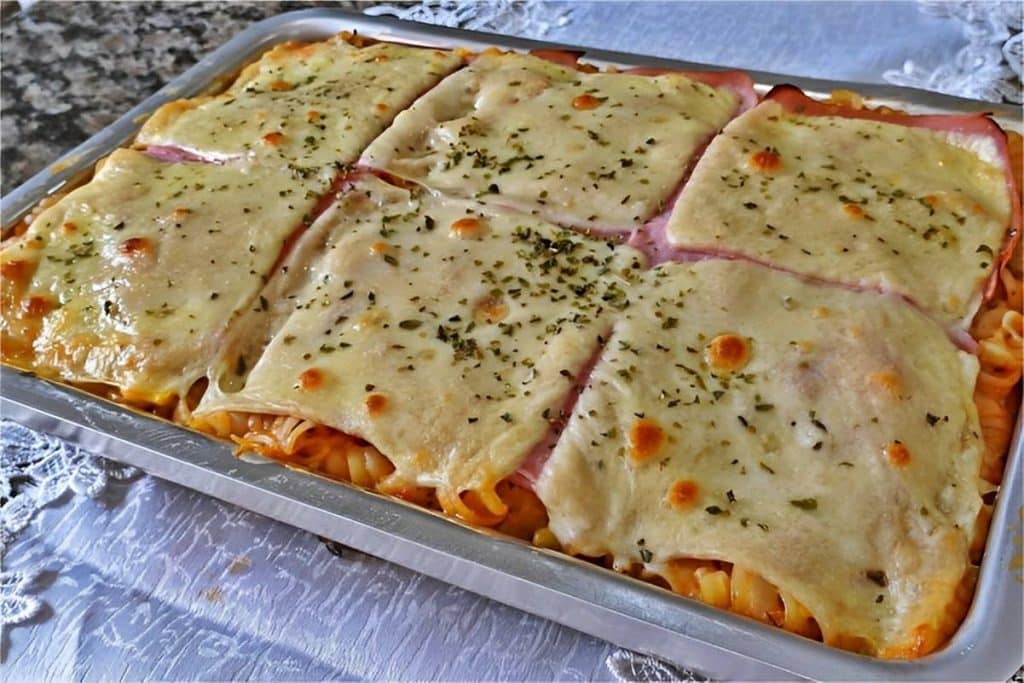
<box><xmin>362</xmin><ymin>53</ymin><xmax>739</xmax><ymax>230</ymax></box>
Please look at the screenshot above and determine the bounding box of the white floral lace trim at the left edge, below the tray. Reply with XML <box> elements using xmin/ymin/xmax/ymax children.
<box><xmin>0</xmin><ymin>420</ymin><xmax>138</xmax><ymax>626</ymax></box>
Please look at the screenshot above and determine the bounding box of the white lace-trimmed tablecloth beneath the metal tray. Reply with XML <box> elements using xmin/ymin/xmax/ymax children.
<box><xmin>0</xmin><ymin>2</ymin><xmax>1021</xmax><ymax>681</ymax></box>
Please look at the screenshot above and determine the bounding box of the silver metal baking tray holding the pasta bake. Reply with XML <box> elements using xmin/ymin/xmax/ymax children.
<box><xmin>0</xmin><ymin>9</ymin><xmax>1024</xmax><ymax>681</ymax></box>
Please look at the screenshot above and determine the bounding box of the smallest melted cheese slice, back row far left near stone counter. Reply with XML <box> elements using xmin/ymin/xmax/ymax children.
<box><xmin>136</xmin><ymin>39</ymin><xmax>460</xmax><ymax>168</ymax></box>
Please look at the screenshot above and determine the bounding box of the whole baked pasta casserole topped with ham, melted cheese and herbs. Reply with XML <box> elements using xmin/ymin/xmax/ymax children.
<box><xmin>0</xmin><ymin>34</ymin><xmax>1024</xmax><ymax>658</ymax></box>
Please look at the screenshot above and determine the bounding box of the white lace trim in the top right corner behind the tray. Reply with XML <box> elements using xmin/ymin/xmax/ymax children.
<box><xmin>883</xmin><ymin>0</ymin><xmax>1024</xmax><ymax>104</ymax></box>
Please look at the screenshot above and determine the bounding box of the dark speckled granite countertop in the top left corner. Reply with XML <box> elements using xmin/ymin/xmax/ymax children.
<box><xmin>0</xmin><ymin>1</ymin><xmax>372</xmax><ymax>195</ymax></box>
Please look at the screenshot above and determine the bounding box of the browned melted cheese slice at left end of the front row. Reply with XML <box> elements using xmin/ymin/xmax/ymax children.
<box><xmin>0</xmin><ymin>150</ymin><xmax>325</xmax><ymax>397</ymax></box>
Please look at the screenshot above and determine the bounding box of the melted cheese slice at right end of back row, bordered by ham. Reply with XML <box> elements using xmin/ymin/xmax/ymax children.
<box><xmin>667</xmin><ymin>101</ymin><xmax>1011</xmax><ymax>324</ymax></box>
